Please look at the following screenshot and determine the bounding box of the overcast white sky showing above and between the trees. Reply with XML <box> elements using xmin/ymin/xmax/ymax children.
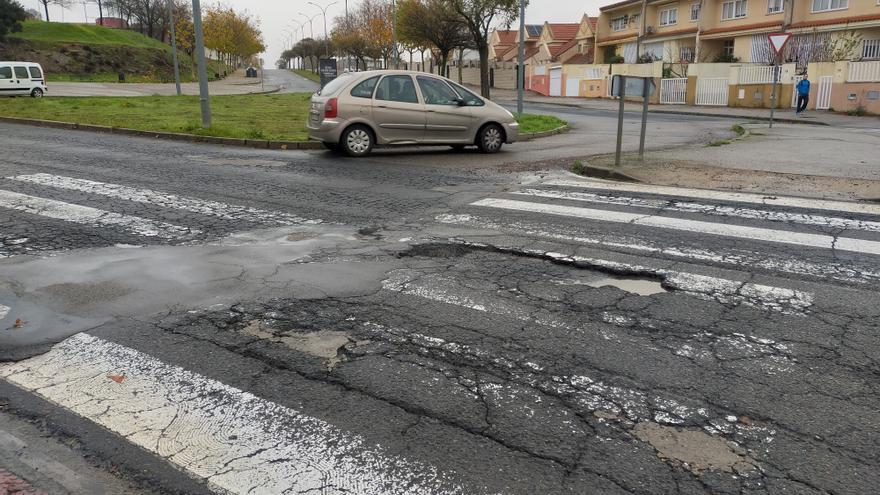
<box><xmin>36</xmin><ymin>0</ymin><xmax>614</xmax><ymax>66</ymax></box>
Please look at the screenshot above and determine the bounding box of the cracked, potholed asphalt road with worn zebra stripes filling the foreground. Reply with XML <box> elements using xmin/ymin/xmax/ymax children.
<box><xmin>0</xmin><ymin>121</ymin><xmax>880</xmax><ymax>495</ymax></box>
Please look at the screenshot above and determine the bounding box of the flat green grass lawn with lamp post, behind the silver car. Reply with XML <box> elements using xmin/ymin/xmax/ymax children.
<box><xmin>0</xmin><ymin>93</ymin><xmax>565</xmax><ymax>141</ymax></box>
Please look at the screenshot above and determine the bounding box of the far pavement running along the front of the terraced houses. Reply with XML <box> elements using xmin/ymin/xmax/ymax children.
<box><xmin>492</xmin><ymin>89</ymin><xmax>880</xmax><ymax>129</ymax></box>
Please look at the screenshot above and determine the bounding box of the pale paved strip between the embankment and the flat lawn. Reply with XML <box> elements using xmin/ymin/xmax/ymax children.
<box><xmin>47</xmin><ymin>71</ymin><xmax>280</xmax><ymax>97</ymax></box>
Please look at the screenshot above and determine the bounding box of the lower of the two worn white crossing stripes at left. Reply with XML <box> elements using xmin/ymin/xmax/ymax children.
<box><xmin>0</xmin><ymin>190</ymin><xmax>201</xmax><ymax>239</ymax></box>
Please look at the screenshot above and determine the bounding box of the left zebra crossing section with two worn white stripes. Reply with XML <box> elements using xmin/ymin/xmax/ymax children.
<box><xmin>0</xmin><ymin>173</ymin><xmax>321</xmax><ymax>258</ymax></box>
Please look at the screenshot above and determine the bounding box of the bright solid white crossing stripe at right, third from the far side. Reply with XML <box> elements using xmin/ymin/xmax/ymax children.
<box><xmin>471</xmin><ymin>198</ymin><xmax>880</xmax><ymax>254</ymax></box>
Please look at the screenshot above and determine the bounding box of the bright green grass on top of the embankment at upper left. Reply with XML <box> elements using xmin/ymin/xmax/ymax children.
<box><xmin>9</xmin><ymin>21</ymin><xmax>170</xmax><ymax>50</ymax></box>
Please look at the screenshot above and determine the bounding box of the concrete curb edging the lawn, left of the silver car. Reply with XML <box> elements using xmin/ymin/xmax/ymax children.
<box><xmin>0</xmin><ymin>116</ymin><xmax>324</xmax><ymax>150</ymax></box>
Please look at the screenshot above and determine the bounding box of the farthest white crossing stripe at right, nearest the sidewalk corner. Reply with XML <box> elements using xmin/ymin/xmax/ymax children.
<box><xmin>543</xmin><ymin>180</ymin><xmax>880</xmax><ymax>215</ymax></box>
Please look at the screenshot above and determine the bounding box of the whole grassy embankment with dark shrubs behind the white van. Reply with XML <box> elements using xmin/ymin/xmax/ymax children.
<box><xmin>0</xmin><ymin>20</ymin><xmax>222</xmax><ymax>82</ymax></box>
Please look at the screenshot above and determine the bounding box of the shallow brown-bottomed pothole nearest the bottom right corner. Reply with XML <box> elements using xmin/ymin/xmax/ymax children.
<box><xmin>633</xmin><ymin>422</ymin><xmax>756</xmax><ymax>473</ymax></box>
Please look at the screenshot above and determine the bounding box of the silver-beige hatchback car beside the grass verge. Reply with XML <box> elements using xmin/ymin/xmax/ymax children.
<box><xmin>306</xmin><ymin>70</ymin><xmax>519</xmax><ymax>156</ymax></box>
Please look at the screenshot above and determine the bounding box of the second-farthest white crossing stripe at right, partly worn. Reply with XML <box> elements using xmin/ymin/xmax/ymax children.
<box><xmin>511</xmin><ymin>189</ymin><xmax>880</xmax><ymax>232</ymax></box>
